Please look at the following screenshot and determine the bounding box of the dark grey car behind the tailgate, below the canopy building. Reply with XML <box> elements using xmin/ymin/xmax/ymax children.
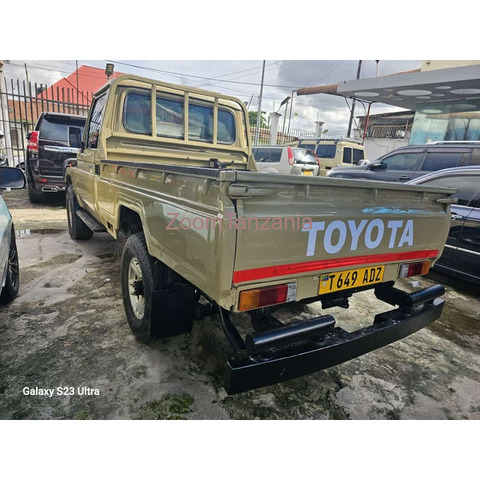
<box><xmin>327</xmin><ymin>142</ymin><xmax>480</xmax><ymax>182</ymax></box>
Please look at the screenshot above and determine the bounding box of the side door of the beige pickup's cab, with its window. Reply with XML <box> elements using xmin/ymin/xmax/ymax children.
<box><xmin>74</xmin><ymin>94</ymin><xmax>106</xmax><ymax>212</ymax></box>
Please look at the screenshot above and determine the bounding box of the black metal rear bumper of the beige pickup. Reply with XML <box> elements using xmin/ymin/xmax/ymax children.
<box><xmin>224</xmin><ymin>284</ymin><xmax>445</xmax><ymax>394</ymax></box>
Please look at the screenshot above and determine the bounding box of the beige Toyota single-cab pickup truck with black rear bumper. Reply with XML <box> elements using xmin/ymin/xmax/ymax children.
<box><xmin>65</xmin><ymin>75</ymin><xmax>454</xmax><ymax>393</ymax></box>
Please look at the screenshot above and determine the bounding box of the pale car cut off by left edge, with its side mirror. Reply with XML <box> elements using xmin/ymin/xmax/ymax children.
<box><xmin>0</xmin><ymin>167</ymin><xmax>25</xmax><ymax>303</ymax></box>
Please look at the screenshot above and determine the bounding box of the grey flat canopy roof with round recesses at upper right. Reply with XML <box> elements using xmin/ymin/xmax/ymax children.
<box><xmin>299</xmin><ymin>65</ymin><xmax>480</xmax><ymax>110</ymax></box>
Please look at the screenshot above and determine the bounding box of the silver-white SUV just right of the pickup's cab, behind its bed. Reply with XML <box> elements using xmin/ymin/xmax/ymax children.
<box><xmin>252</xmin><ymin>145</ymin><xmax>319</xmax><ymax>176</ymax></box>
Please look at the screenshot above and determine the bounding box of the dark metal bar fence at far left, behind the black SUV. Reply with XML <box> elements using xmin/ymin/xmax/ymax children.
<box><xmin>0</xmin><ymin>78</ymin><xmax>92</xmax><ymax>166</ymax></box>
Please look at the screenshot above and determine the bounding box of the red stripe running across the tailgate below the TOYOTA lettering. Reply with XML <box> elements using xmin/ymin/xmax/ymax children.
<box><xmin>233</xmin><ymin>250</ymin><xmax>438</xmax><ymax>283</ymax></box>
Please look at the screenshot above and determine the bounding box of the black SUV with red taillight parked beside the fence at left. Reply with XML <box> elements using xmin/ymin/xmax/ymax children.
<box><xmin>25</xmin><ymin>112</ymin><xmax>86</xmax><ymax>203</ymax></box>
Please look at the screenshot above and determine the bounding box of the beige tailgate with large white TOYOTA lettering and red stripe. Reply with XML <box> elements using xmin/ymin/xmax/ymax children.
<box><xmin>229</xmin><ymin>172</ymin><xmax>454</xmax><ymax>292</ymax></box>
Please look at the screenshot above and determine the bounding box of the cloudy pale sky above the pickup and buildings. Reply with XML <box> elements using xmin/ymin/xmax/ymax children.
<box><xmin>4</xmin><ymin>58</ymin><xmax>422</xmax><ymax>135</ymax></box>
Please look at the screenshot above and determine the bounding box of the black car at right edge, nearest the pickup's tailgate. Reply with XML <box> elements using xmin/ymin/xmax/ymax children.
<box><xmin>407</xmin><ymin>166</ymin><xmax>480</xmax><ymax>283</ymax></box>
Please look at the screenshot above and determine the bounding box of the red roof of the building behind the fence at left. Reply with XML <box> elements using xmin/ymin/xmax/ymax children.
<box><xmin>37</xmin><ymin>65</ymin><xmax>122</xmax><ymax>104</ymax></box>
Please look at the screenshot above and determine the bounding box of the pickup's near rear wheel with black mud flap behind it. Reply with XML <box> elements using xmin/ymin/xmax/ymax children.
<box><xmin>121</xmin><ymin>232</ymin><xmax>199</xmax><ymax>343</ymax></box>
